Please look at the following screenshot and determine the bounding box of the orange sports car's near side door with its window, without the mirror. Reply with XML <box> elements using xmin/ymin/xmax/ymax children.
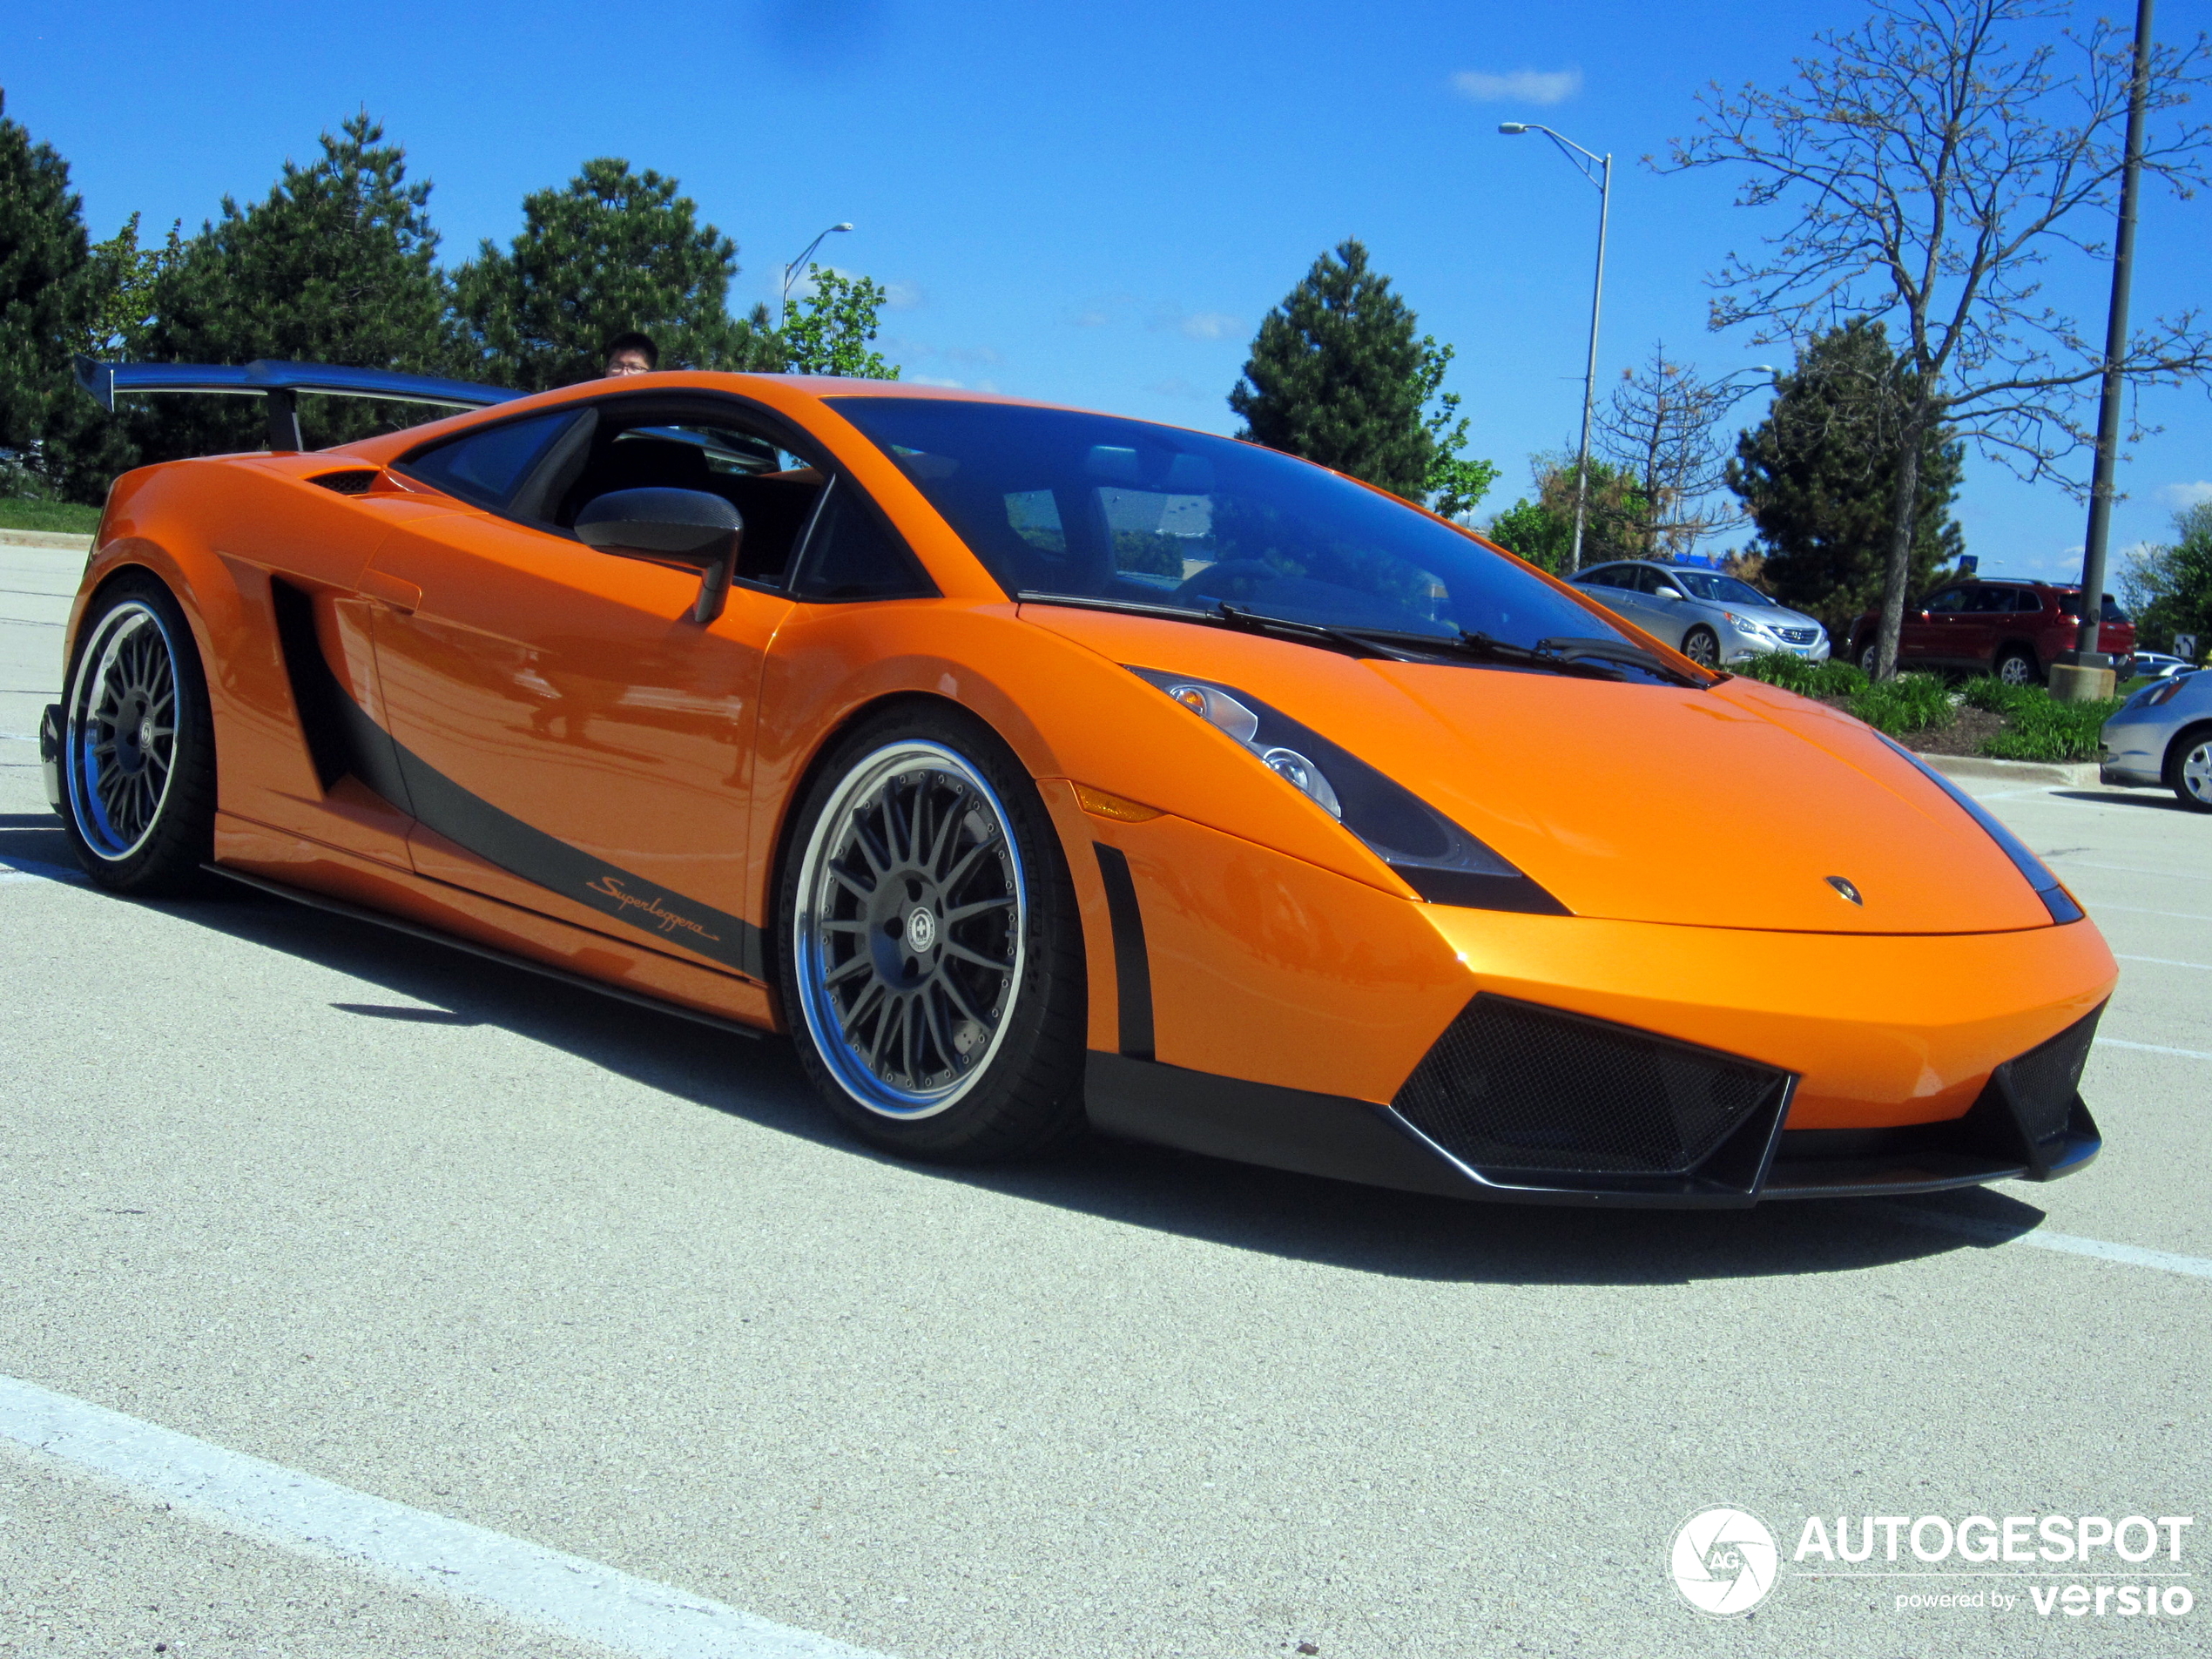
<box><xmin>365</xmin><ymin>402</ymin><xmax>819</xmax><ymax>975</ymax></box>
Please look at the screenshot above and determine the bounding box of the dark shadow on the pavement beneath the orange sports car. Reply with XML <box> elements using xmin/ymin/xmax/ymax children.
<box><xmin>0</xmin><ymin>816</ymin><xmax>2044</xmax><ymax>1285</ymax></box>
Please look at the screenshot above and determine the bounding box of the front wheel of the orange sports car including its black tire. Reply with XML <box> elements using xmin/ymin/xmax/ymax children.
<box><xmin>774</xmin><ymin>704</ymin><xmax>1089</xmax><ymax>1163</ymax></box>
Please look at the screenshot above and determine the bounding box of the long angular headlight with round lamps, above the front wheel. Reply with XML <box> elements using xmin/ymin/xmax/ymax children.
<box><xmin>1130</xmin><ymin>666</ymin><xmax>1570</xmax><ymax>916</ymax></box>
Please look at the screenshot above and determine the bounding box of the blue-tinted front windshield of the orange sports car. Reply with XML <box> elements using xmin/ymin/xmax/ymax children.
<box><xmin>832</xmin><ymin>398</ymin><xmax>1623</xmax><ymax>646</ymax></box>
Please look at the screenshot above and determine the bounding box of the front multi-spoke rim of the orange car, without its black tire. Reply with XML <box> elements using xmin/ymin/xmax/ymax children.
<box><xmin>794</xmin><ymin>741</ymin><xmax>1027</xmax><ymax>1117</ymax></box>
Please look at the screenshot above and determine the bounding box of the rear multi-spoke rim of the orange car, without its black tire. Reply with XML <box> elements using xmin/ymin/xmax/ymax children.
<box><xmin>62</xmin><ymin>599</ymin><xmax>179</xmax><ymax>865</ymax></box>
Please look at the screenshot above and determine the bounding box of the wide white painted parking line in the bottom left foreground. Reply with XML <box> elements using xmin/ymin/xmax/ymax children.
<box><xmin>0</xmin><ymin>1378</ymin><xmax>882</xmax><ymax>1659</ymax></box>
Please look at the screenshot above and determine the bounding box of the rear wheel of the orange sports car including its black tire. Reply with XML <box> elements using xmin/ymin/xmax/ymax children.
<box><xmin>62</xmin><ymin>570</ymin><xmax>214</xmax><ymax>898</ymax></box>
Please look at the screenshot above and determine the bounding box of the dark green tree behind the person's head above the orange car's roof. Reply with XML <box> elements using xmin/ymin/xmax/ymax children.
<box><xmin>454</xmin><ymin>157</ymin><xmax>783</xmax><ymax>392</ymax></box>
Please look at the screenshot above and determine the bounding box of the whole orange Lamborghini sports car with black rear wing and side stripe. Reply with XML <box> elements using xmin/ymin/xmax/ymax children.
<box><xmin>42</xmin><ymin>363</ymin><xmax>2114</xmax><ymax>1205</ymax></box>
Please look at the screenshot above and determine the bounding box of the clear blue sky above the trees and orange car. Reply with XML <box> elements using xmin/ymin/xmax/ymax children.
<box><xmin>4</xmin><ymin>0</ymin><xmax>2212</xmax><ymax>577</ymax></box>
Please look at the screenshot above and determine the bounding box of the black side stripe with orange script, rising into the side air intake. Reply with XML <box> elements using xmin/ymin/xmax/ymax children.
<box><xmin>270</xmin><ymin>582</ymin><xmax>765</xmax><ymax>981</ymax></box>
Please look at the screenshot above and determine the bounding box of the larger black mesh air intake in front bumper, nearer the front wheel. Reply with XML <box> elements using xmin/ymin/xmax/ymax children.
<box><xmin>1392</xmin><ymin>993</ymin><xmax>1790</xmax><ymax>1177</ymax></box>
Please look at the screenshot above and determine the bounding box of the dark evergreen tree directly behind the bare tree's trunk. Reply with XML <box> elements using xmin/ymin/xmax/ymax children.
<box><xmin>1728</xmin><ymin>319</ymin><xmax>1966</xmax><ymax>632</ymax></box>
